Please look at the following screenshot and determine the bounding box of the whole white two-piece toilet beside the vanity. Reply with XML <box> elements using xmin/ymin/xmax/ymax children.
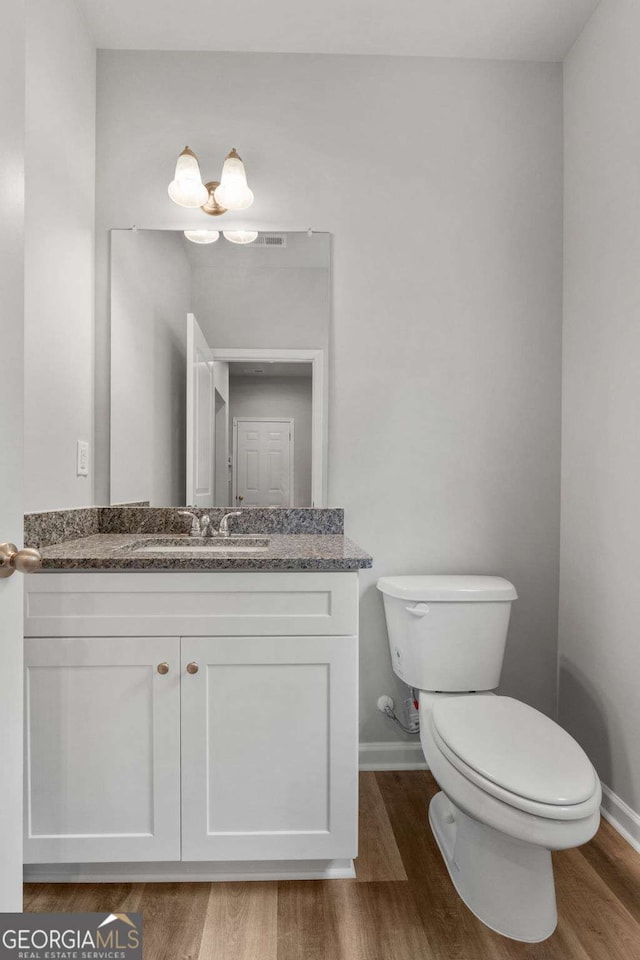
<box><xmin>378</xmin><ymin>576</ymin><xmax>601</xmax><ymax>942</ymax></box>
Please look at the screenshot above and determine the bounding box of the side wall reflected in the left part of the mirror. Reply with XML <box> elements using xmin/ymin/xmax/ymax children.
<box><xmin>110</xmin><ymin>230</ymin><xmax>191</xmax><ymax>506</ymax></box>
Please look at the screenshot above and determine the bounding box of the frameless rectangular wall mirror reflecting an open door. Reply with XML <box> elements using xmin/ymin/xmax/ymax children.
<box><xmin>110</xmin><ymin>230</ymin><xmax>331</xmax><ymax>507</ymax></box>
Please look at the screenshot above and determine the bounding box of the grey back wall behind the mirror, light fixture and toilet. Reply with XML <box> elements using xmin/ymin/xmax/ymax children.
<box><xmin>96</xmin><ymin>51</ymin><xmax>562</xmax><ymax>741</ymax></box>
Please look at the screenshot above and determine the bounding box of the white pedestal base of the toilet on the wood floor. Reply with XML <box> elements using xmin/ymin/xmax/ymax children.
<box><xmin>429</xmin><ymin>791</ymin><xmax>558</xmax><ymax>943</ymax></box>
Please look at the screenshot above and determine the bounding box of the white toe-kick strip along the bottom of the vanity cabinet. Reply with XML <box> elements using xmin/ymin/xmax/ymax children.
<box><xmin>24</xmin><ymin>860</ymin><xmax>356</xmax><ymax>883</ymax></box>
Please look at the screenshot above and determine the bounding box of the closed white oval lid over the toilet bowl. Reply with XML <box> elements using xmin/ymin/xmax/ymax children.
<box><xmin>432</xmin><ymin>696</ymin><xmax>596</xmax><ymax>806</ymax></box>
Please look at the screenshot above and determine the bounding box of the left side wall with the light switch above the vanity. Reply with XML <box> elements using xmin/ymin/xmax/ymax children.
<box><xmin>25</xmin><ymin>0</ymin><xmax>96</xmax><ymax>510</ymax></box>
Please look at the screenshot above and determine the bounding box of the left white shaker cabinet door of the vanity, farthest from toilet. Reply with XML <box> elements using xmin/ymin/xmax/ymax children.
<box><xmin>24</xmin><ymin>637</ymin><xmax>180</xmax><ymax>863</ymax></box>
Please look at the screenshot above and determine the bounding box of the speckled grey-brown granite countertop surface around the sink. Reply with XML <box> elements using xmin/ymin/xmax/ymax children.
<box><xmin>41</xmin><ymin>533</ymin><xmax>373</xmax><ymax>571</ymax></box>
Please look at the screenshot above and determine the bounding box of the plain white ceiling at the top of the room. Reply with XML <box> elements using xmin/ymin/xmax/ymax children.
<box><xmin>80</xmin><ymin>0</ymin><xmax>599</xmax><ymax>60</ymax></box>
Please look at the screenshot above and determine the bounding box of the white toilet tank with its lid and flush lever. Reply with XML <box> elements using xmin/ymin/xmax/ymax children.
<box><xmin>377</xmin><ymin>576</ymin><xmax>518</xmax><ymax>693</ymax></box>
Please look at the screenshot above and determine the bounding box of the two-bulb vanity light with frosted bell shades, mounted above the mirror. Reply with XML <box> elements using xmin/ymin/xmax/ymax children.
<box><xmin>169</xmin><ymin>147</ymin><xmax>253</xmax><ymax>217</ymax></box>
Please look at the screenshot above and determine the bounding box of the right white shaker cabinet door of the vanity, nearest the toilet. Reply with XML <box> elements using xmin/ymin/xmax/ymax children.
<box><xmin>182</xmin><ymin>637</ymin><xmax>358</xmax><ymax>860</ymax></box>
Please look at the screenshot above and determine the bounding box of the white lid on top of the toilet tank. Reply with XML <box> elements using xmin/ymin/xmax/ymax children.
<box><xmin>377</xmin><ymin>575</ymin><xmax>518</xmax><ymax>603</ymax></box>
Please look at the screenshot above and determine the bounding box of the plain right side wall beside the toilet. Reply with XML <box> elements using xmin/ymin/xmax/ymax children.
<box><xmin>560</xmin><ymin>0</ymin><xmax>640</xmax><ymax>816</ymax></box>
